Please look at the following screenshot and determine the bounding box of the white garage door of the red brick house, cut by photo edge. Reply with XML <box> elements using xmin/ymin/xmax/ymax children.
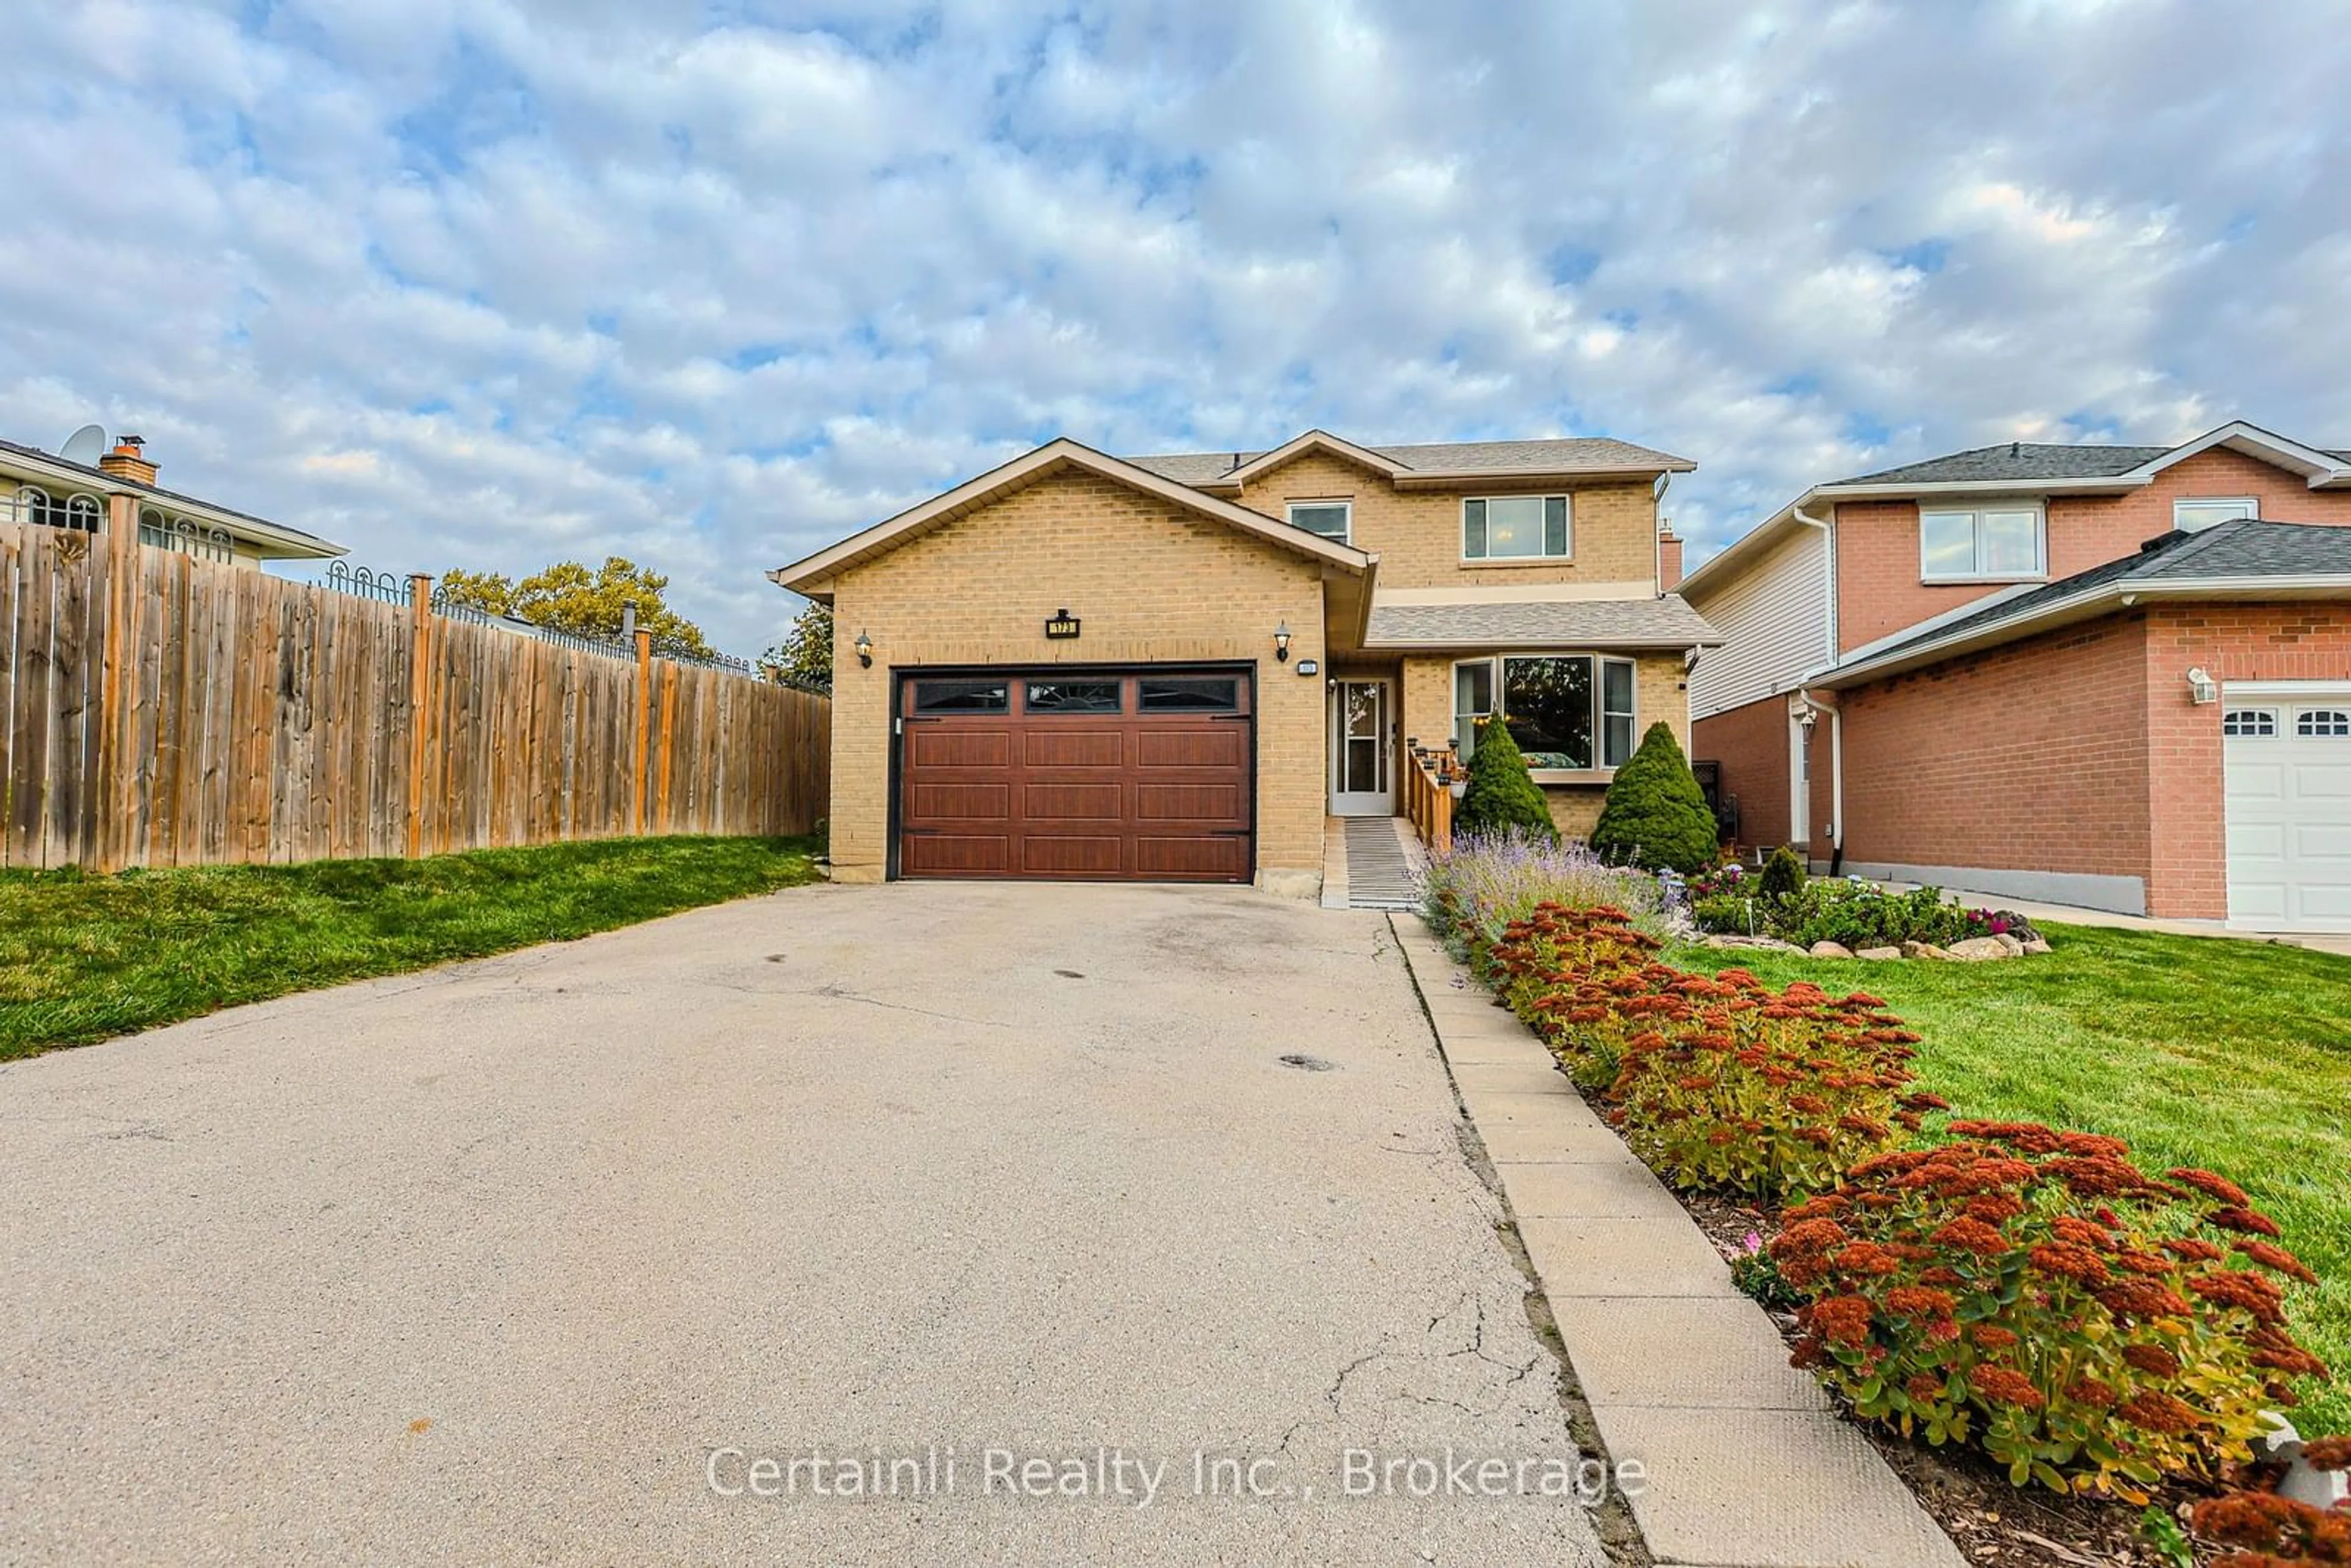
<box><xmin>2222</xmin><ymin>681</ymin><xmax>2351</xmax><ymax>931</ymax></box>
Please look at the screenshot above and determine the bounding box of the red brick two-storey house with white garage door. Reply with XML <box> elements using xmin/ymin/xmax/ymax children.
<box><xmin>1681</xmin><ymin>423</ymin><xmax>2351</xmax><ymax>931</ymax></box>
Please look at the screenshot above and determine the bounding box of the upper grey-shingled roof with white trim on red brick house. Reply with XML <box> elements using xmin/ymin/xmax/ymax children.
<box><xmin>1681</xmin><ymin>418</ymin><xmax>2351</xmax><ymax>593</ymax></box>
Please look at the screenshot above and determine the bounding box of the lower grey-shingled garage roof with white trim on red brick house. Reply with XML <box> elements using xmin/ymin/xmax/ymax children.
<box><xmin>1808</xmin><ymin>517</ymin><xmax>2351</xmax><ymax>686</ymax></box>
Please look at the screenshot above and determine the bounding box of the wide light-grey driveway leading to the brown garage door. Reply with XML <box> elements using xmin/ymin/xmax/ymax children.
<box><xmin>0</xmin><ymin>884</ymin><xmax>1601</xmax><ymax>1563</ymax></box>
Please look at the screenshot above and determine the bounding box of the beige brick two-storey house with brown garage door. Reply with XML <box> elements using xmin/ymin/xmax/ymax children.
<box><xmin>769</xmin><ymin>430</ymin><xmax>1716</xmax><ymax>896</ymax></box>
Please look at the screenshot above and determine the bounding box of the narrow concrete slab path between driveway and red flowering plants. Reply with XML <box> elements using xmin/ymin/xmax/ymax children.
<box><xmin>1394</xmin><ymin>915</ymin><xmax>1965</xmax><ymax>1568</ymax></box>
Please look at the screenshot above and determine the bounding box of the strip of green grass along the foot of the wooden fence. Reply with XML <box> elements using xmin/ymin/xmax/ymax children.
<box><xmin>0</xmin><ymin>839</ymin><xmax>816</xmax><ymax>1060</ymax></box>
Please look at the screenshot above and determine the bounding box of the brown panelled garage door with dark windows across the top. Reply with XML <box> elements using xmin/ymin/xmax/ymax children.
<box><xmin>898</xmin><ymin>667</ymin><xmax>1256</xmax><ymax>882</ymax></box>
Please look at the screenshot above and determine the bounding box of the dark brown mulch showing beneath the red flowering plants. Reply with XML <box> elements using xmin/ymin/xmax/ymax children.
<box><xmin>1676</xmin><ymin>1192</ymin><xmax>2219</xmax><ymax>1568</ymax></box>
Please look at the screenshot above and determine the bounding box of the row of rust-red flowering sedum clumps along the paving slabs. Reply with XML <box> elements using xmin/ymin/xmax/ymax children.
<box><xmin>1453</xmin><ymin>901</ymin><xmax>2325</xmax><ymax>1500</ymax></box>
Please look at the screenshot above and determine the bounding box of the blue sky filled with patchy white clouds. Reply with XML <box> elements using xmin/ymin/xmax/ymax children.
<box><xmin>0</xmin><ymin>0</ymin><xmax>2351</xmax><ymax>651</ymax></box>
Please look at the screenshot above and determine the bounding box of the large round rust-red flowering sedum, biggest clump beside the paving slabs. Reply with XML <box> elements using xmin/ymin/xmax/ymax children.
<box><xmin>1771</xmin><ymin>1121</ymin><xmax>2325</xmax><ymax>1502</ymax></box>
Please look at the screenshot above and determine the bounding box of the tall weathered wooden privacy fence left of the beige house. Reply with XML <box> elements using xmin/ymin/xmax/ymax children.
<box><xmin>0</xmin><ymin>498</ymin><xmax>832</xmax><ymax>872</ymax></box>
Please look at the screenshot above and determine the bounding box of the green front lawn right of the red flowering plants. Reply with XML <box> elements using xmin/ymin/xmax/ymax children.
<box><xmin>1671</xmin><ymin>926</ymin><xmax>2351</xmax><ymax>1434</ymax></box>
